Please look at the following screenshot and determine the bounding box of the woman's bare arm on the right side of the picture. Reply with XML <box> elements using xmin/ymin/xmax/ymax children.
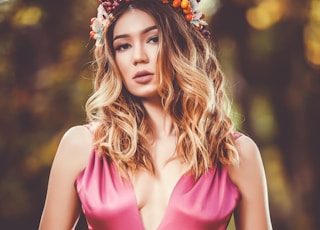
<box><xmin>229</xmin><ymin>135</ymin><xmax>272</xmax><ymax>230</ymax></box>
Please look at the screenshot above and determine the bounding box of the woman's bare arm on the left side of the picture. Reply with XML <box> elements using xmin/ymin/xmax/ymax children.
<box><xmin>39</xmin><ymin>126</ymin><xmax>92</xmax><ymax>230</ymax></box>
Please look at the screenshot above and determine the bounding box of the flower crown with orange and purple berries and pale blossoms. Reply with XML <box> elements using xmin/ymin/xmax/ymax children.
<box><xmin>90</xmin><ymin>0</ymin><xmax>210</xmax><ymax>46</ymax></box>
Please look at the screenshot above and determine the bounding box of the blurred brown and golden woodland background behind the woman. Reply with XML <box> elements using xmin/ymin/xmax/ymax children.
<box><xmin>0</xmin><ymin>0</ymin><xmax>320</xmax><ymax>230</ymax></box>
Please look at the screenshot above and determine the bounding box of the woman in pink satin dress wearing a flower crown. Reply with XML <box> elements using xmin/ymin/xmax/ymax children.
<box><xmin>40</xmin><ymin>0</ymin><xmax>272</xmax><ymax>230</ymax></box>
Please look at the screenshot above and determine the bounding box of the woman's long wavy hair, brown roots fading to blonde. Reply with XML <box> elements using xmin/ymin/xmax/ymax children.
<box><xmin>86</xmin><ymin>0</ymin><xmax>239</xmax><ymax>178</ymax></box>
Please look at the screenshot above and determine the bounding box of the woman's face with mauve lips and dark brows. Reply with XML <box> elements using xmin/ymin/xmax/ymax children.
<box><xmin>113</xmin><ymin>9</ymin><xmax>159</xmax><ymax>99</ymax></box>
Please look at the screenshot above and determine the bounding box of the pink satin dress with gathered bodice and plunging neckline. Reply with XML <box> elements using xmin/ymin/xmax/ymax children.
<box><xmin>75</xmin><ymin>147</ymin><xmax>241</xmax><ymax>230</ymax></box>
